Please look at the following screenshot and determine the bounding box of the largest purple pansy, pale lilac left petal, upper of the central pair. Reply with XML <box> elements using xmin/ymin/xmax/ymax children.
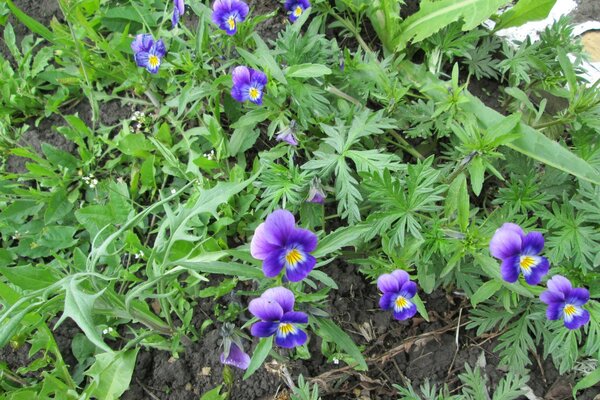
<box><xmin>250</xmin><ymin>210</ymin><xmax>317</xmax><ymax>282</ymax></box>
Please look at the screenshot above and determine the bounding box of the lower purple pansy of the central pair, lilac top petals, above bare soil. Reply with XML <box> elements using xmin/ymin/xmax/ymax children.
<box><xmin>248</xmin><ymin>287</ymin><xmax>308</xmax><ymax>348</ymax></box>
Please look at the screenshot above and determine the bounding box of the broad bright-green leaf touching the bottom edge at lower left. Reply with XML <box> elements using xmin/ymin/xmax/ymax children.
<box><xmin>85</xmin><ymin>349</ymin><xmax>139</xmax><ymax>400</ymax></box>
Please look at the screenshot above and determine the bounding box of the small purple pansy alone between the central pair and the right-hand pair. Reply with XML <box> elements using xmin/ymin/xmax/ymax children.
<box><xmin>377</xmin><ymin>269</ymin><xmax>417</xmax><ymax>321</ymax></box>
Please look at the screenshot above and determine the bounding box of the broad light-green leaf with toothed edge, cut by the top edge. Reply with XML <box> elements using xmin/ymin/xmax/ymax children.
<box><xmin>395</xmin><ymin>0</ymin><xmax>509</xmax><ymax>49</ymax></box>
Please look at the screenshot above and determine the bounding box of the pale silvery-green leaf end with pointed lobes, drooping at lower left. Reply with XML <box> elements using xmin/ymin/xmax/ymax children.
<box><xmin>56</xmin><ymin>278</ymin><xmax>112</xmax><ymax>353</ymax></box>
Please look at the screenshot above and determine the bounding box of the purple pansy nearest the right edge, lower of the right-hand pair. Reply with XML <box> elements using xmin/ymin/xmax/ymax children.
<box><xmin>540</xmin><ymin>275</ymin><xmax>590</xmax><ymax>329</ymax></box>
